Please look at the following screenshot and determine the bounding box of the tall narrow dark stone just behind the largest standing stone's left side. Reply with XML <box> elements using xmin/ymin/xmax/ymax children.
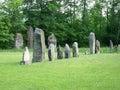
<box><xmin>27</xmin><ymin>26</ymin><xmax>33</xmax><ymax>48</ymax></box>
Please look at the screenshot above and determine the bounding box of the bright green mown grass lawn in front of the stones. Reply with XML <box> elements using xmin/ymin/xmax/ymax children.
<box><xmin>0</xmin><ymin>50</ymin><xmax>120</xmax><ymax>90</ymax></box>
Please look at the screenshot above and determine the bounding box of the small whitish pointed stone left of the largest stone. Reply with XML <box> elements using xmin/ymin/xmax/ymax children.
<box><xmin>20</xmin><ymin>47</ymin><xmax>31</xmax><ymax>65</ymax></box>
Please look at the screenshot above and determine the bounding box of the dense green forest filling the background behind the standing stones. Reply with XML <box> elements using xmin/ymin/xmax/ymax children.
<box><xmin>0</xmin><ymin>0</ymin><xmax>120</xmax><ymax>49</ymax></box>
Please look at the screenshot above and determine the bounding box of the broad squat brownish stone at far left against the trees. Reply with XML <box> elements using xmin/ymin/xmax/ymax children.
<box><xmin>15</xmin><ymin>33</ymin><xmax>23</xmax><ymax>49</ymax></box>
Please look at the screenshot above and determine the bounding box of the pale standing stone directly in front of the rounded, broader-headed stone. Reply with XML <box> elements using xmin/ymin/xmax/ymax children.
<box><xmin>48</xmin><ymin>44</ymin><xmax>55</xmax><ymax>61</ymax></box>
